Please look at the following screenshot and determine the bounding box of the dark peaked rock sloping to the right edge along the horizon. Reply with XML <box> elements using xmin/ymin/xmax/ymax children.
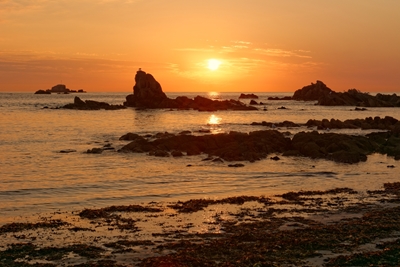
<box><xmin>292</xmin><ymin>81</ymin><xmax>400</xmax><ymax>107</ymax></box>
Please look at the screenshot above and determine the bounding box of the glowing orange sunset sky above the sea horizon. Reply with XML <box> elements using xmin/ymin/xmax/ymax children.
<box><xmin>0</xmin><ymin>0</ymin><xmax>400</xmax><ymax>93</ymax></box>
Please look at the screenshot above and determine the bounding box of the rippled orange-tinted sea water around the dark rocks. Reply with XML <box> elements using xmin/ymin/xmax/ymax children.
<box><xmin>0</xmin><ymin>93</ymin><xmax>400</xmax><ymax>224</ymax></box>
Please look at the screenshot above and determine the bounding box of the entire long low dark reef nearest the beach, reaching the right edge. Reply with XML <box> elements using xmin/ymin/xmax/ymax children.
<box><xmin>119</xmin><ymin>130</ymin><xmax>400</xmax><ymax>163</ymax></box>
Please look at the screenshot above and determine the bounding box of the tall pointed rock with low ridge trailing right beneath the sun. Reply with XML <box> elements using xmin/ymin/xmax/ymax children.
<box><xmin>124</xmin><ymin>69</ymin><xmax>257</xmax><ymax>111</ymax></box>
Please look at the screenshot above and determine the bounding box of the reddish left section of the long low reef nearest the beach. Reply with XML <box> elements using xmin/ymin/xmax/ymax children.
<box><xmin>119</xmin><ymin>130</ymin><xmax>290</xmax><ymax>162</ymax></box>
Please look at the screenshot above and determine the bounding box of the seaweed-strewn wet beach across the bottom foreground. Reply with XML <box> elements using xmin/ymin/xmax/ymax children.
<box><xmin>0</xmin><ymin>182</ymin><xmax>400</xmax><ymax>266</ymax></box>
